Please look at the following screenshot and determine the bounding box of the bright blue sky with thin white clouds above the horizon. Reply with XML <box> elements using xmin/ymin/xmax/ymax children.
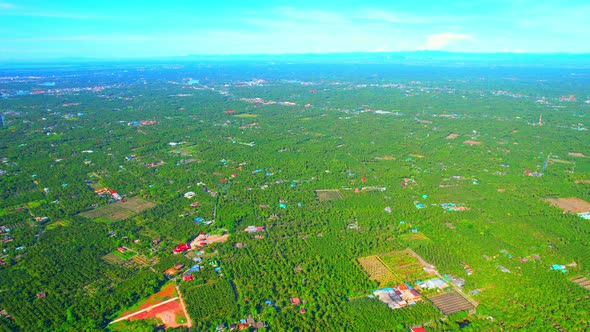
<box><xmin>0</xmin><ymin>0</ymin><xmax>590</xmax><ymax>60</ymax></box>
